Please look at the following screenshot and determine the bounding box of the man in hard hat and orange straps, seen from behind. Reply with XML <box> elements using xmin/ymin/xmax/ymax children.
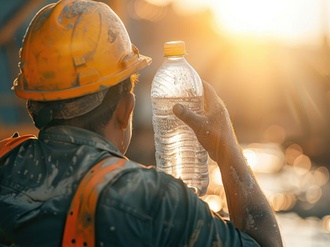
<box><xmin>0</xmin><ymin>0</ymin><xmax>282</xmax><ymax>247</ymax></box>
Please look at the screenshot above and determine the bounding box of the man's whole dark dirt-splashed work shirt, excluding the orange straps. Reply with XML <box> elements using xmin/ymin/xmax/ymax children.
<box><xmin>0</xmin><ymin>126</ymin><xmax>259</xmax><ymax>247</ymax></box>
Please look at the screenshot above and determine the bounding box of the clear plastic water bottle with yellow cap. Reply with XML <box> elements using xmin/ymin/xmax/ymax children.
<box><xmin>151</xmin><ymin>41</ymin><xmax>209</xmax><ymax>196</ymax></box>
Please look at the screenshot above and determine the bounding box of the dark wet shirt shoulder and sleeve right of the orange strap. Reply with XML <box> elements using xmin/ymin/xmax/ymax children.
<box><xmin>96</xmin><ymin>164</ymin><xmax>259</xmax><ymax>247</ymax></box>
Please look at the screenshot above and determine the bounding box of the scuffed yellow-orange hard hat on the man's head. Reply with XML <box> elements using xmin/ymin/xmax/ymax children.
<box><xmin>13</xmin><ymin>0</ymin><xmax>151</xmax><ymax>101</ymax></box>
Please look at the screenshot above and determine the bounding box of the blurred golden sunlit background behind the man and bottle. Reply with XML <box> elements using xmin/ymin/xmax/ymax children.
<box><xmin>0</xmin><ymin>0</ymin><xmax>330</xmax><ymax>247</ymax></box>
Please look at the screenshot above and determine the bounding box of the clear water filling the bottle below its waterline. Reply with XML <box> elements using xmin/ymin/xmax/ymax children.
<box><xmin>152</xmin><ymin>96</ymin><xmax>208</xmax><ymax>195</ymax></box>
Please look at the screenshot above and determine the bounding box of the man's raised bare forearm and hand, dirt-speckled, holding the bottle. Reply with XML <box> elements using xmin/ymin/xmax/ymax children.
<box><xmin>173</xmin><ymin>82</ymin><xmax>282</xmax><ymax>247</ymax></box>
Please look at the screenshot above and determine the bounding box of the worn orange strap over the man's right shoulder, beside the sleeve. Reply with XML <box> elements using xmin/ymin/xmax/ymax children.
<box><xmin>62</xmin><ymin>158</ymin><xmax>126</xmax><ymax>247</ymax></box>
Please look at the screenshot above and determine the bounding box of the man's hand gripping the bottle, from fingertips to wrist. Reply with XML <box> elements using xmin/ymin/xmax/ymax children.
<box><xmin>173</xmin><ymin>82</ymin><xmax>236</xmax><ymax>161</ymax></box>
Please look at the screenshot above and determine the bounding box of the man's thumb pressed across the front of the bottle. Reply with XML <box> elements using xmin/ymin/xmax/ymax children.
<box><xmin>173</xmin><ymin>104</ymin><xmax>204</xmax><ymax>133</ymax></box>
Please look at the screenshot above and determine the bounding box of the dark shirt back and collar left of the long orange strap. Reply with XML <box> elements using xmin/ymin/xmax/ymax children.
<box><xmin>0</xmin><ymin>126</ymin><xmax>122</xmax><ymax>246</ymax></box>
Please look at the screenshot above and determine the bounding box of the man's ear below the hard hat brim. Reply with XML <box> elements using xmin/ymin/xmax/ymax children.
<box><xmin>114</xmin><ymin>93</ymin><xmax>135</xmax><ymax>129</ymax></box>
